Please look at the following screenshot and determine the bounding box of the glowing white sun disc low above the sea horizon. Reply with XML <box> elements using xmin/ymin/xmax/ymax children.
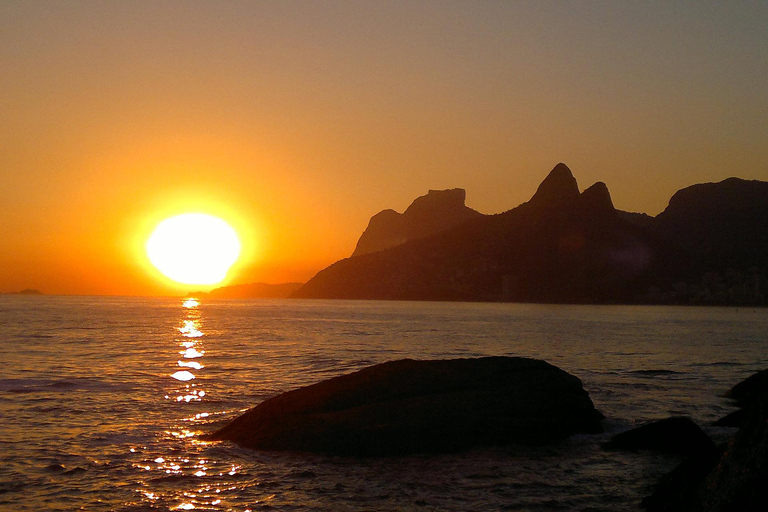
<box><xmin>146</xmin><ymin>213</ymin><xmax>240</xmax><ymax>285</ymax></box>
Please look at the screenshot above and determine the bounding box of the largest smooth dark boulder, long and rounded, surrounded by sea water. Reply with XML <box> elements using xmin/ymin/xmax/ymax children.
<box><xmin>209</xmin><ymin>357</ymin><xmax>603</xmax><ymax>456</ymax></box>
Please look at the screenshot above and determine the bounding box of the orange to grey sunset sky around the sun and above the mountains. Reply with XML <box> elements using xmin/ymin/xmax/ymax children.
<box><xmin>0</xmin><ymin>0</ymin><xmax>768</xmax><ymax>295</ymax></box>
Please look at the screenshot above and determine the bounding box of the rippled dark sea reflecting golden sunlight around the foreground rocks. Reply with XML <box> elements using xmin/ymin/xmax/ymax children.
<box><xmin>0</xmin><ymin>296</ymin><xmax>768</xmax><ymax>511</ymax></box>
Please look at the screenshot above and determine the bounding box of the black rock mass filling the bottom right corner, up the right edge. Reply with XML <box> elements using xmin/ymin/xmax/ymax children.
<box><xmin>643</xmin><ymin>371</ymin><xmax>768</xmax><ymax>512</ymax></box>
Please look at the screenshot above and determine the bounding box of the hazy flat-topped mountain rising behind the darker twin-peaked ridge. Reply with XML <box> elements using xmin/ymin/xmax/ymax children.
<box><xmin>352</xmin><ymin>188</ymin><xmax>482</xmax><ymax>256</ymax></box>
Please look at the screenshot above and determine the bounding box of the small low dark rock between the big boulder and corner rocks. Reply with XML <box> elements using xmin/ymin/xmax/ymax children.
<box><xmin>605</xmin><ymin>417</ymin><xmax>715</xmax><ymax>456</ymax></box>
